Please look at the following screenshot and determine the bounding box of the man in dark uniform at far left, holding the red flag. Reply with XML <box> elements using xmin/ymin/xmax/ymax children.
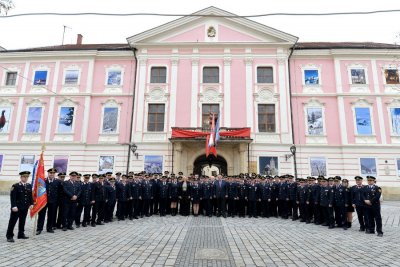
<box><xmin>6</xmin><ymin>171</ymin><xmax>33</xmax><ymax>242</ymax></box>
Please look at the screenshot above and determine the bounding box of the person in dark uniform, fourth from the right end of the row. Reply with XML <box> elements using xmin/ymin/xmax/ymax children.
<box><xmin>334</xmin><ymin>176</ymin><xmax>348</xmax><ymax>230</ymax></box>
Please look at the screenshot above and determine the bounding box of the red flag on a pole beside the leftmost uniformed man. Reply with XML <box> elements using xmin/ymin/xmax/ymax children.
<box><xmin>30</xmin><ymin>152</ymin><xmax>47</xmax><ymax>218</ymax></box>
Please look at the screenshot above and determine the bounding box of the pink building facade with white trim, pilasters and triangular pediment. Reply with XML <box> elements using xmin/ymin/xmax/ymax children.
<box><xmin>0</xmin><ymin>7</ymin><xmax>400</xmax><ymax>198</ymax></box>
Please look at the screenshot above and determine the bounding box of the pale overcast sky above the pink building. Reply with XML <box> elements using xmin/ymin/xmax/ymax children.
<box><xmin>0</xmin><ymin>0</ymin><xmax>400</xmax><ymax>49</ymax></box>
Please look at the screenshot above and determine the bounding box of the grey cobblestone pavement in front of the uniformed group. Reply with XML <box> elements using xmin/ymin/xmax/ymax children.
<box><xmin>0</xmin><ymin>196</ymin><xmax>400</xmax><ymax>267</ymax></box>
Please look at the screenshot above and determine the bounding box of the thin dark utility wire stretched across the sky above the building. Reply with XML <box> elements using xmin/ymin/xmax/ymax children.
<box><xmin>0</xmin><ymin>9</ymin><xmax>400</xmax><ymax>19</ymax></box>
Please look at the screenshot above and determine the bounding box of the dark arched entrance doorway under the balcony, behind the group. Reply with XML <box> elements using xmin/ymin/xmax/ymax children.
<box><xmin>193</xmin><ymin>154</ymin><xmax>228</xmax><ymax>176</ymax></box>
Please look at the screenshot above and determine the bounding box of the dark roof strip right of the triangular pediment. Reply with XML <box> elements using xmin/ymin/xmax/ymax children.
<box><xmin>295</xmin><ymin>42</ymin><xmax>400</xmax><ymax>50</ymax></box>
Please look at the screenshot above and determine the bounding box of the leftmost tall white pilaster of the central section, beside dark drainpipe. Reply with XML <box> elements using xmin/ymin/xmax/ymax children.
<box><xmin>134</xmin><ymin>59</ymin><xmax>147</xmax><ymax>134</ymax></box>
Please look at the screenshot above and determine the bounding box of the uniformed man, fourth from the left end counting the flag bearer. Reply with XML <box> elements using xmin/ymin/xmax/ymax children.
<box><xmin>63</xmin><ymin>172</ymin><xmax>81</xmax><ymax>231</ymax></box>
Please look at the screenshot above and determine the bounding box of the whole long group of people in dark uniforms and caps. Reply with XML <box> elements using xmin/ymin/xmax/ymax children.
<box><xmin>6</xmin><ymin>168</ymin><xmax>383</xmax><ymax>242</ymax></box>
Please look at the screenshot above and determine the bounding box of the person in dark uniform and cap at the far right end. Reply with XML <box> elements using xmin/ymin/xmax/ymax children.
<box><xmin>363</xmin><ymin>176</ymin><xmax>383</xmax><ymax>237</ymax></box>
